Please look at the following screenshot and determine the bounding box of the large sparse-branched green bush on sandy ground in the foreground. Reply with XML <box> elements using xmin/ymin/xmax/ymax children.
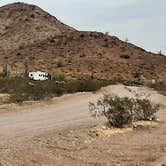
<box><xmin>89</xmin><ymin>95</ymin><xmax>160</xmax><ymax>128</ymax></box>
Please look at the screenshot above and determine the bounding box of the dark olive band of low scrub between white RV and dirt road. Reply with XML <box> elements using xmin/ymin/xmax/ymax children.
<box><xmin>0</xmin><ymin>75</ymin><xmax>109</xmax><ymax>102</ymax></box>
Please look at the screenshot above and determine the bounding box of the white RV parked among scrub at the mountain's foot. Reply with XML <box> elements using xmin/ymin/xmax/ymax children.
<box><xmin>28</xmin><ymin>71</ymin><xmax>49</xmax><ymax>81</ymax></box>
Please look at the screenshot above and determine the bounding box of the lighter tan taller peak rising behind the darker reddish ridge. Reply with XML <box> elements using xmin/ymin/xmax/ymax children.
<box><xmin>0</xmin><ymin>3</ymin><xmax>74</xmax><ymax>50</ymax></box>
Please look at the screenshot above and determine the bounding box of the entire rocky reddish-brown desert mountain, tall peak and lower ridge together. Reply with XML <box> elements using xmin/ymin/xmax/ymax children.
<box><xmin>0</xmin><ymin>3</ymin><xmax>166</xmax><ymax>80</ymax></box>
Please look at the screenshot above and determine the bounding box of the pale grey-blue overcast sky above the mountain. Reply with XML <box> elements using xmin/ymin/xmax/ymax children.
<box><xmin>0</xmin><ymin>0</ymin><xmax>166</xmax><ymax>54</ymax></box>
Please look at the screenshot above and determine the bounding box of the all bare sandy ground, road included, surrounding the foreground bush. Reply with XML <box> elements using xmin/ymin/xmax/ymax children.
<box><xmin>0</xmin><ymin>85</ymin><xmax>166</xmax><ymax>166</ymax></box>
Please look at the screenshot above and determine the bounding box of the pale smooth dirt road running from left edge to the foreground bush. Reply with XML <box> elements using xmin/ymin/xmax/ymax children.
<box><xmin>0</xmin><ymin>93</ymin><xmax>99</xmax><ymax>139</ymax></box>
